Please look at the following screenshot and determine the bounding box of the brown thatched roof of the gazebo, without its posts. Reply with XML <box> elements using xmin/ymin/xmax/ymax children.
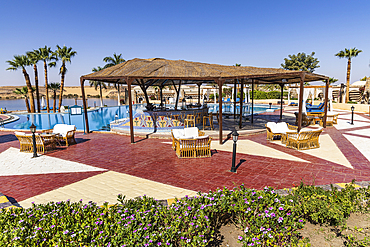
<box><xmin>81</xmin><ymin>58</ymin><xmax>327</xmax><ymax>85</ymax></box>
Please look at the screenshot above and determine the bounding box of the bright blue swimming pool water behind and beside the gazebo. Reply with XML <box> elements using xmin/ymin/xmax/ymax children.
<box><xmin>4</xmin><ymin>104</ymin><xmax>277</xmax><ymax>131</ymax></box>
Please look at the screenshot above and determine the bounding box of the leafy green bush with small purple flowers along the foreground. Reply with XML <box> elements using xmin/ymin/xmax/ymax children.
<box><xmin>0</xmin><ymin>186</ymin><xmax>310</xmax><ymax>246</ymax></box>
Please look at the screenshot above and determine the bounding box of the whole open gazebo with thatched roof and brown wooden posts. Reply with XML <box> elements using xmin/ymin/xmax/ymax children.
<box><xmin>80</xmin><ymin>58</ymin><xmax>329</xmax><ymax>143</ymax></box>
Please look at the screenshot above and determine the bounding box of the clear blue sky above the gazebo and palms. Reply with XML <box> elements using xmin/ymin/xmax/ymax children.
<box><xmin>0</xmin><ymin>0</ymin><xmax>370</xmax><ymax>86</ymax></box>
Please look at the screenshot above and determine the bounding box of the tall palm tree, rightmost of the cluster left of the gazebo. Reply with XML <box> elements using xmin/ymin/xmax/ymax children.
<box><xmin>55</xmin><ymin>45</ymin><xmax>77</xmax><ymax>110</ymax></box>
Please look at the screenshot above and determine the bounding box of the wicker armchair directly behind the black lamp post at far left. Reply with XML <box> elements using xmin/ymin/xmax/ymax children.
<box><xmin>14</xmin><ymin>132</ymin><xmax>56</xmax><ymax>153</ymax></box>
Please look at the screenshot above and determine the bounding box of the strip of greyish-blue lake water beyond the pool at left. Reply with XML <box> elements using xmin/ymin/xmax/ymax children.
<box><xmin>0</xmin><ymin>98</ymin><xmax>118</xmax><ymax>111</ymax></box>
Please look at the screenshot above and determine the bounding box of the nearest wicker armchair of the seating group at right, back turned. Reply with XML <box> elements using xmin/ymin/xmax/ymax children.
<box><xmin>286</xmin><ymin>129</ymin><xmax>322</xmax><ymax>150</ymax></box>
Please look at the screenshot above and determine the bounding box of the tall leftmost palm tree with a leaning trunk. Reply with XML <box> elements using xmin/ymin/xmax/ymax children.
<box><xmin>6</xmin><ymin>55</ymin><xmax>35</xmax><ymax>113</ymax></box>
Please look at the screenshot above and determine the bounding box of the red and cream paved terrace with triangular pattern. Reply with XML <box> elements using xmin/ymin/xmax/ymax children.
<box><xmin>0</xmin><ymin>108</ymin><xmax>370</xmax><ymax>207</ymax></box>
